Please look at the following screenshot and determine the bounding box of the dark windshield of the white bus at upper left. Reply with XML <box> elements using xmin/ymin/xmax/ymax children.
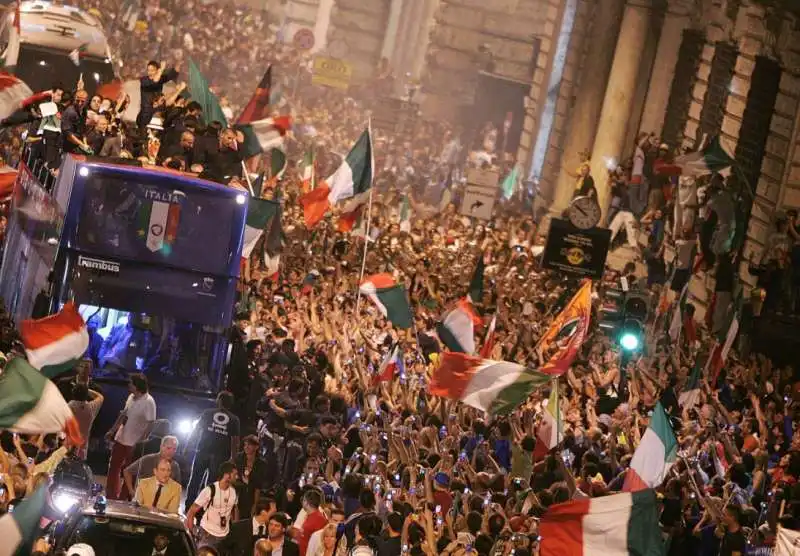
<box><xmin>15</xmin><ymin>43</ymin><xmax>114</xmax><ymax>94</ymax></box>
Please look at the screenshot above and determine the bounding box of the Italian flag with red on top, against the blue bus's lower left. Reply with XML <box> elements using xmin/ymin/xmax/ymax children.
<box><xmin>20</xmin><ymin>301</ymin><xmax>89</xmax><ymax>378</ymax></box>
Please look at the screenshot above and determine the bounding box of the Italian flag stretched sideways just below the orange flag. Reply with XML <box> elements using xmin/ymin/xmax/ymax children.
<box><xmin>429</xmin><ymin>352</ymin><xmax>551</xmax><ymax>414</ymax></box>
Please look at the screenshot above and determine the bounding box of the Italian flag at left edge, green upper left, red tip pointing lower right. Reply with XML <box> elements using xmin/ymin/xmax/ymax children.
<box><xmin>0</xmin><ymin>357</ymin><xmax>83</xmax><ymax>446</ymax></box>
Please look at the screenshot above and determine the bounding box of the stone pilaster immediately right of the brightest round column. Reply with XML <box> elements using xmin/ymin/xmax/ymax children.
<box><xmin>639</xmin><ymin>0</ymin><xmax>692</xmax><ymax>138</ymax></box>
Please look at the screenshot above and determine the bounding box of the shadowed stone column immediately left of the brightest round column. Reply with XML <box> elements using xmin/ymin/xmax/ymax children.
<box><xmin>545</xmin><ymin>0</ymin><xmax>625</xmax><ymax>216</ymax></box>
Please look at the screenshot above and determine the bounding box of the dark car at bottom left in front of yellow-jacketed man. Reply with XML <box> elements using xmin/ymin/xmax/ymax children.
<box><xmin>53</xmin><ymin>497</ymin><xmax>197</xmax><ymax>556</ymax></box>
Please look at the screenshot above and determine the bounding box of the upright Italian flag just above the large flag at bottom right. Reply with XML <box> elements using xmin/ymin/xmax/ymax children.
<box><xmin>622</xmin><ymin>402</ymin><xmax>678</xmax><ymax>492</ymax></box>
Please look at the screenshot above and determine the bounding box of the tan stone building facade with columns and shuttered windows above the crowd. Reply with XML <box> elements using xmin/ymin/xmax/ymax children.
<box><xmin>296</xmin><ymin>0</ymin><xmax>800</xmax><ymax>312</ymax></box>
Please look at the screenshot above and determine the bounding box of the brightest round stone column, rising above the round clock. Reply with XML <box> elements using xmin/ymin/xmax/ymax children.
<box><xmin>592</xmin><ymin>0</ymin><xmax>652</xmax><ymax>214</ymax></box>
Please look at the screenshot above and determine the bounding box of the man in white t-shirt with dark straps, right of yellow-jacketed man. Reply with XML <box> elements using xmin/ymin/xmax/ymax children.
<box><xmin>186</xmin><ymin>461</ymin><xmax>239</xmax><ymax>547</ymax></box>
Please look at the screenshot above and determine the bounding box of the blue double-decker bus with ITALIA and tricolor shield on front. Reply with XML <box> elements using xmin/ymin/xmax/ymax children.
<box><xmin>0</xmin><ymin>155</ymin><xmax>248</xmax><ymax>454</ymax></box>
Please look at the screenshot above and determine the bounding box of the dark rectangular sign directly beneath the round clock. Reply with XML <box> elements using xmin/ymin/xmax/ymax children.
<box><xmin>542</xmin><ymin>218</ymin><xmax>611</xmax><ymax>279</ymax></box>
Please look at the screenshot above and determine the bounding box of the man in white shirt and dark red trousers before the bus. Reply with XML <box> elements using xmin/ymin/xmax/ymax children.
<box><xmin>106</xmin><ymin>374</ymin><xmax>156</xmax><ymax>500</ymax></box>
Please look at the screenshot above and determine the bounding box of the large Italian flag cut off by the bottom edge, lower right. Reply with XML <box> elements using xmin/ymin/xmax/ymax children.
<box><xmin>539</xmin><ymin>490</ymin><xmax>664</xmax><ymax>556</ymax></box>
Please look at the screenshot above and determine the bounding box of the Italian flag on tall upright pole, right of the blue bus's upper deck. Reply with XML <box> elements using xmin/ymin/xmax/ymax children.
<box><xmin>300</xmin><ymin>128</ymin><xmax>375</xmax><ymax>229</ymax></box>
